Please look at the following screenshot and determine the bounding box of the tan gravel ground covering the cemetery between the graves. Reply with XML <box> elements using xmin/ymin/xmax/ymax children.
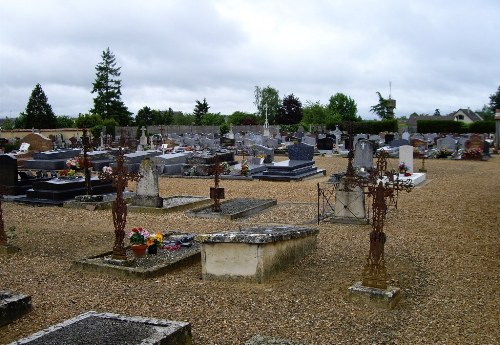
<box><xmin>0</xmin><ymin>156</ymin><xmax>500</xmax><ymax>345</ymax></box>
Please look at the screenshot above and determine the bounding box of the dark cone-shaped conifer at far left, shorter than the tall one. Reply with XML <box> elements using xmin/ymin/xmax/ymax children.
<box><xmin>23</xmin><ymin>84</ymin><xmax>57</xmax><ymax>128</ymax></box>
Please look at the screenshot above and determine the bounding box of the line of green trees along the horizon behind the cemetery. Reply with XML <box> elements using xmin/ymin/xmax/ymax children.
<box><xmin>3</xmin><ymin>47</ymin><xmax>500</xmax><ymax>136</ymax></box>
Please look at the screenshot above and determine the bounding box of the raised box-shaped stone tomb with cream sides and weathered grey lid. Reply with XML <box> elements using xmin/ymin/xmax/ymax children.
<box><xmin>198</xmin><ymin>226</ymin><xmax>319</xmax><ymax>283</ymax></box>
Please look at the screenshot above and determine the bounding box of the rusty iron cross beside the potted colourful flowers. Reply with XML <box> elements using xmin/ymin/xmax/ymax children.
<box><xmin>99</xmin><ymin>147</ymin><xmax>142</xmax><ymax>260</ymax></box>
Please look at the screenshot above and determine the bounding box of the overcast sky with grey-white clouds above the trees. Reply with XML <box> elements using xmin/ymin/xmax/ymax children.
<box><xmin>0</xmin><ymin>0</ymin><xmax>500</xmax><ymax>119</ymax></box>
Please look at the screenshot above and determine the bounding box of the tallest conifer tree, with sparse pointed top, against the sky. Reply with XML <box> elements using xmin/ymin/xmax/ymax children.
<box><xmin>90</xmin><ymin>47</ymin><xmax>132</xmax><ymax>126</ymax></box>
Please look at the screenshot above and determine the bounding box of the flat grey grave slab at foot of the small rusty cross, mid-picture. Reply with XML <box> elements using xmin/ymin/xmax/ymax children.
<box><xmin>186</xmin><ymin>198</ymin><xmax>278</xmax><ymax>219</ymax></box>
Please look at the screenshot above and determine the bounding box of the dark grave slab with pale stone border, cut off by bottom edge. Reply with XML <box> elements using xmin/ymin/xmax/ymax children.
<box><xmin>12</xmin><ymin>311</ymin><xmax>192</xmax><ymax>345</ymax></box>
